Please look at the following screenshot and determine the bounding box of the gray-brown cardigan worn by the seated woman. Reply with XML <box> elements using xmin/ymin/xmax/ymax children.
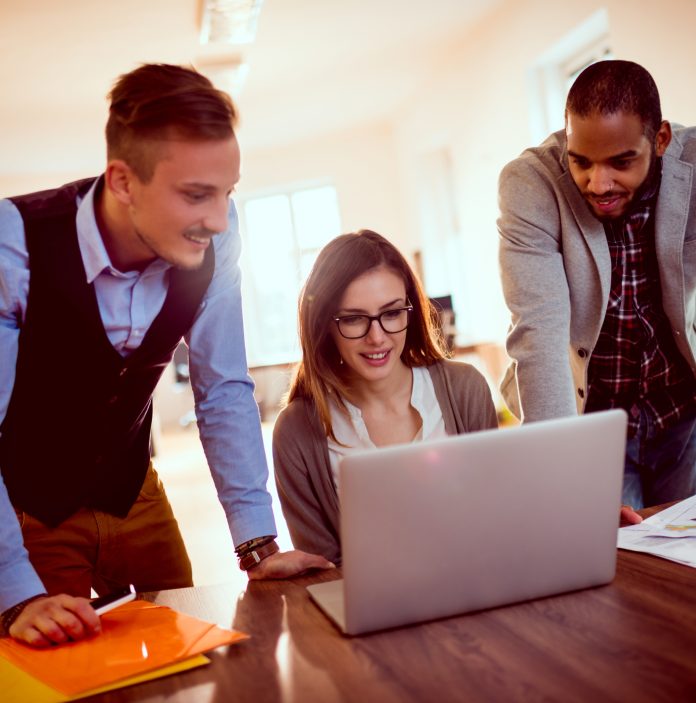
<box><xmin>273</xmin><ymin>361</ymin><xmax>498</xmax><ymax>564</ymax></box>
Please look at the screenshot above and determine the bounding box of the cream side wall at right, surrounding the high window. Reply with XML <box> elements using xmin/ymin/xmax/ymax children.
<box><xmin>396</xmin><ymin>0</ymin><xmax>696</xmax><ymax>340</ymax></box>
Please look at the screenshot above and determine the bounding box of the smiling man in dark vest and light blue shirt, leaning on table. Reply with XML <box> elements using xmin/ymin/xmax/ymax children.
<box><xmin>0</xmin><ymin>64</ymin><xmax>331</xmax><ymax>646</ymax></box>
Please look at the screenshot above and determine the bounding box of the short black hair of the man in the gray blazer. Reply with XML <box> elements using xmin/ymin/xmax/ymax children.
<box><xmin>566</xmin><ymin>60</ymin><xmax>662</xmax><ymax>141</ymax></box>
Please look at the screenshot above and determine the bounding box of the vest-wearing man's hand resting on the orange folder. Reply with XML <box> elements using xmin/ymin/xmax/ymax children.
<box><xmin>9</xmin><ymin>594</ymin><xmax>101</xmax><ymax>647</ymax></box>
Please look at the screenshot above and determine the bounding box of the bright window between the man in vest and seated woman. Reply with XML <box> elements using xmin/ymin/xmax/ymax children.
<box><xmin>239</xmin><ymin>185</ymin><xmax>341</xmax><ymax>366</ymax></box>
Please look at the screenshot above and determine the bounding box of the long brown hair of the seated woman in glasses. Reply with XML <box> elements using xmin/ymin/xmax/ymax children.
<box><xmin>288</xmin><ymin>229</ymin><xmax>446</xmax><ymax>439</ymax></box>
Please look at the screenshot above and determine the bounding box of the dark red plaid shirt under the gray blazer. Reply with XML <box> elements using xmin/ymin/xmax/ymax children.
<box><xmin>586</xmin><ymin>171</ymin><xmax>696</xmax><ymax>437</ymax></box>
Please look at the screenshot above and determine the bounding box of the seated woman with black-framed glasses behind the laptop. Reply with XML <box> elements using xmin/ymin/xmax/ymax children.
<box><xmin>273</xmin><ymin>230</ymin><xmax>497</xmax><ymax>563</ymax></box>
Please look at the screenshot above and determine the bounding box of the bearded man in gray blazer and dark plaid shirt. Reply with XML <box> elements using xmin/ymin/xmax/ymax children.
<box><xmin>498</xmin><ymin>61</ymin><xmax>696</xmax><ymax>518</ymax></box>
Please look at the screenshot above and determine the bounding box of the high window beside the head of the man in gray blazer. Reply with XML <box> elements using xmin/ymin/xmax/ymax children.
<box><xmin>529</xmin><ymin>9</ymin><xmax>613</xmax><ymax>143</ymax></box>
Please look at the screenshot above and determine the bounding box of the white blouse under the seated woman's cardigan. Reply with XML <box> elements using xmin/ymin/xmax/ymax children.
<box><xmin>327</xmin><ymin>366</ymin><xmax>447</xmax><ymax>490</ymax></box>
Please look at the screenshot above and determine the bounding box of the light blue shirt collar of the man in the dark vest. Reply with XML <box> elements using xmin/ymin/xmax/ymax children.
<box><xmin>75</xmin><ymin>176</ymin><xmax>171</xmax><ymax>283</ymax></box>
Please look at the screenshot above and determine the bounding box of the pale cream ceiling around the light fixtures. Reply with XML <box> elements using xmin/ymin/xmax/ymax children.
<box><xmin>0</xmin><ymin>0</ymin><xmax>502</xmax><ymax>179</ymax></box>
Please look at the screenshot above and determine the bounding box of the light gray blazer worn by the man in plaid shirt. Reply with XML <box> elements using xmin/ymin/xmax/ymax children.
<box><xmin>498</xmin><ymin>125</ymin><xmax>696</xmax><ymax>421</ymax></box>
